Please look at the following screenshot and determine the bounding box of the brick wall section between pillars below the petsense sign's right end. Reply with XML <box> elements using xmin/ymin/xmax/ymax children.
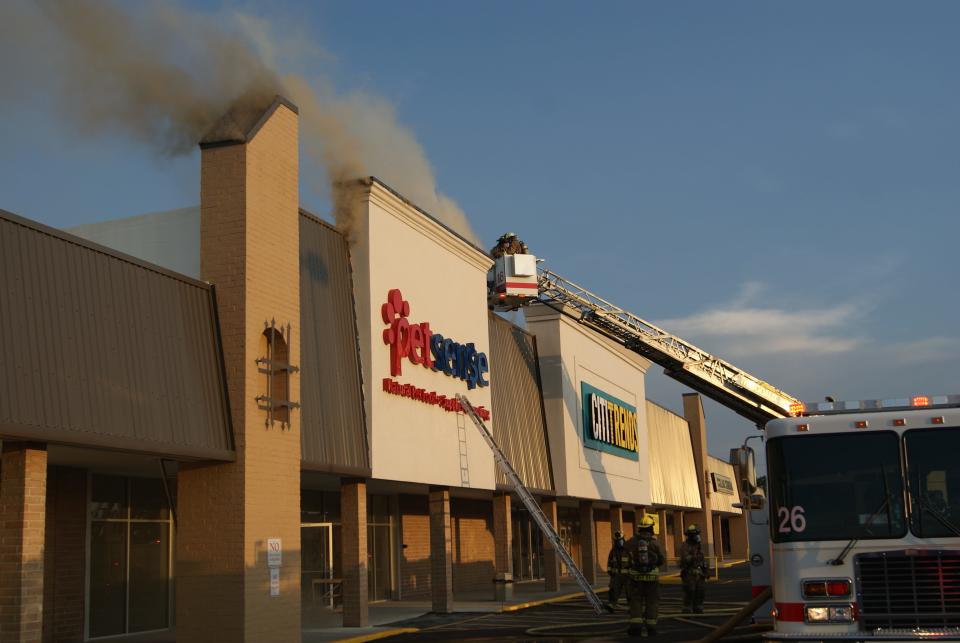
<box><xmin>450</xmin><ymin>498</ymin><xmax>495</xmax><ymax>592</ymax></box>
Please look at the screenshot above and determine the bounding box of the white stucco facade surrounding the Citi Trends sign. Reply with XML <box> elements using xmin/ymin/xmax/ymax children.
<box><xmin>524</xmin><ymin>306</ymin><xmax>651</xmax><ymax>505</ymax></box>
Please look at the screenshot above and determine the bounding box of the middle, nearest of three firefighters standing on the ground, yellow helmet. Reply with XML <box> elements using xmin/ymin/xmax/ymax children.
<box><xmin>626</xmin><ymin>515</ymin><xmax>666</xmax><ymax>636</ymax></box>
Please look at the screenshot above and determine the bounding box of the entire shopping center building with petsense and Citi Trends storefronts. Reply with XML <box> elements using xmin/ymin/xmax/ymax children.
<box><xmin>0</xmin><ymin>99</ymin><xmax>747</xmax><ymax>641</ymax></box>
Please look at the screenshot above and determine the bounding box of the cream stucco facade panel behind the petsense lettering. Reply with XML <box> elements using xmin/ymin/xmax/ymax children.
<box><xmin>350</xmin><ymin>181</ymin><xmax>496</xmax><ymax>489</ymax></box>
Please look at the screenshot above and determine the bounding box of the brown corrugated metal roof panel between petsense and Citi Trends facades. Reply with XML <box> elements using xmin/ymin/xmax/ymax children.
<box><xmin>490</xmin><ymin>313</ymin><xmax>554</xmax><ymax>491</ymax></box>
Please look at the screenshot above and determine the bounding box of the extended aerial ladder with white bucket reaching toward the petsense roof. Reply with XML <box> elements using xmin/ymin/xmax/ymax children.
<box><xmin>487</xmin><ymin>254</ymin><xmax>802</xmax><ymax>429</ymax></box>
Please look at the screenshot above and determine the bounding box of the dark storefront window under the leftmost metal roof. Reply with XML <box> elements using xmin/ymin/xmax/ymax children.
<box><xmin>88</xmin><ymin>475</ymin><xmax>171</xmax><ymax>638</ymax></box>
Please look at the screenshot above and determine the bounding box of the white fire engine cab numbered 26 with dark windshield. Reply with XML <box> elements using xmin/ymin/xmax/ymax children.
<box><xmin>751</xmin><ymin>395</ymin><xmax>960</xmax><ymax>641</ymax></box>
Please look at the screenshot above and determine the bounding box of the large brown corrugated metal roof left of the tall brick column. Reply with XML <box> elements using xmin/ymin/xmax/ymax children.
<box><xmin>0</xmin><ymin>210</ymin><xmax>233</xmax><ymax>460</ymax></box>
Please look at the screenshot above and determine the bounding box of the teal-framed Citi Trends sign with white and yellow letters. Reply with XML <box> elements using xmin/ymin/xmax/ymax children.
<box><xmin>580</xmin><ymin>382</ymin><xmax>640</xmax><ymax>460</ymax></box>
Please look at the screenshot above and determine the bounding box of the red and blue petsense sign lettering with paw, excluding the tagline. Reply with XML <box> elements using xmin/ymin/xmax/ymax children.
<box><xmin>380</xmin><ymin>288</ymin><xmax>490</xmax><ymax>390</ymax></box>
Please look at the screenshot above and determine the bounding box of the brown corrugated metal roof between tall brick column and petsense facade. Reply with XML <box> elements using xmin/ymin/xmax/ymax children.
<box><xmin>300</xmin><ymin>211</ymin><xmax>370</xmax><ymax>476</ymax></box>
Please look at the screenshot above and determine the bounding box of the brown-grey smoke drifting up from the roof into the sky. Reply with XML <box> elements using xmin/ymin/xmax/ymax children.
<box><xmin>0</xmin><ymin>0</ymin><xmax>477</xmax><ymax>243</ymax></box>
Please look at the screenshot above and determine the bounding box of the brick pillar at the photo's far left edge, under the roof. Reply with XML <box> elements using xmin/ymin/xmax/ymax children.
<box><xmin>0</xmin><ymin>442</ymin><xmax>47</xmax><ymax>643</ymax></box>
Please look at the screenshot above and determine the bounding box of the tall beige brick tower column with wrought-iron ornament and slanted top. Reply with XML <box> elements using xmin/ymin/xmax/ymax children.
<box><xmin>176</xmin><ymin>101</ymin><xmax>301</xmax><ymax>643</ymax></box>
